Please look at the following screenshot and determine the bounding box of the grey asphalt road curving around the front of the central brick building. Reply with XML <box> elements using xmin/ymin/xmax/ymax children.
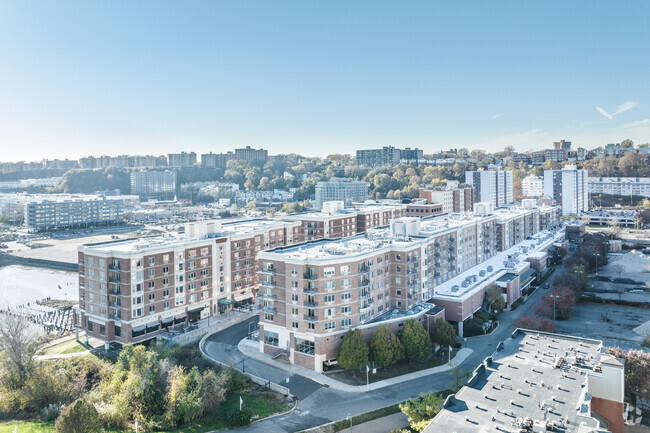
<box><xmin>204</xmin><ymin>266</ymin><xmax>562</xmax><ymax>433</ymax></box>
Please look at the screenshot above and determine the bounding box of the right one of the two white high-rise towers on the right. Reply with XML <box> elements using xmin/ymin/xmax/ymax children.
<box><xmin>544</xmin><ymin>165</ymin><xmax>589</xmax><ymax>215</ymax></box>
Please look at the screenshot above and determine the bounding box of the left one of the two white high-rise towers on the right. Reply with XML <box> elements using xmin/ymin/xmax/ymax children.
<box><xmin>465</xmin><ymin>169</ymin><xmax>514</xmax><ymax>207</ymax></box>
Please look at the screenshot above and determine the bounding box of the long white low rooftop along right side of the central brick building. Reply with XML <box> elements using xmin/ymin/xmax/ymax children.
<box><xmin>433</xmin><ymin>229</ymin><xmax>564</xmax><ymax>299</ymax></box>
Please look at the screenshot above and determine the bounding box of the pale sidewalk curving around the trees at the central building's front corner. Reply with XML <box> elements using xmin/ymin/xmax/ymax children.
<box><xmin>237</xmin><ymin>339</ymin><xmax>473</xmax><ymax>392</ymax></box>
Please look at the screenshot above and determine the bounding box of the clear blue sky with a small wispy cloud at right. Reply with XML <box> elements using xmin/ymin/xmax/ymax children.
<box><xmin>0</xmin><ymin>0</ymin><xmax>650</xmax><ymax>161</ymax></box>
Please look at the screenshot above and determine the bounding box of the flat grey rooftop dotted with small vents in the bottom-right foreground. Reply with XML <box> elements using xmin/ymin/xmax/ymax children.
<box><xmin>423</xmin><ymin>330</ymin><xmax>608</xmax><ymax>433</ymax></box>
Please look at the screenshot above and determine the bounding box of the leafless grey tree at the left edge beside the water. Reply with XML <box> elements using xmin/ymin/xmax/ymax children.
<box><xmin>0</xmin><ymin>314</ymin><xmax>37</xmax><ymax>380</ymax></box>
